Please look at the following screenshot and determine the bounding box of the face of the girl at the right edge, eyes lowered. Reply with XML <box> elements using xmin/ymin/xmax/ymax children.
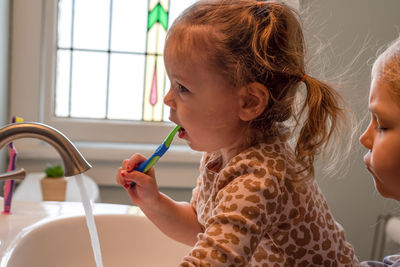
<box><xmin>360</xmin><ymin>75</ymin><xmax>400</xmax><ymax>201</ymax></box>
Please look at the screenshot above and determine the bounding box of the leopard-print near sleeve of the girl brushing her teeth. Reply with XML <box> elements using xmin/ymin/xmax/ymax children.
<box><xmin>181</xmin><ymin>162</ymin><xmax>279</xmax><ymax>266</ymax></box>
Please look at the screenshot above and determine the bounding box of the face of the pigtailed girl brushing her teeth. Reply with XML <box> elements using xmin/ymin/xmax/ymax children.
<box><xmin>164</xmin><ymin>41</ymin><xmax>244</xmax><ymax>155</ymax></box>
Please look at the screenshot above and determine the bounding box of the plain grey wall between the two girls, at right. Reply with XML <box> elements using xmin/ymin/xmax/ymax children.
<box><xmin>304</xmin><ymin>0</ymin><xmax>400</xmax><ymax>259</ymax></box>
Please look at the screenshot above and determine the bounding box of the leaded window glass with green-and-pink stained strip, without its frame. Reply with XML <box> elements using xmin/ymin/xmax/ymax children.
<box><xmin>54</xmin><ymin>0</ymin><xmax>192</xmax><ymax>121</ymax></box>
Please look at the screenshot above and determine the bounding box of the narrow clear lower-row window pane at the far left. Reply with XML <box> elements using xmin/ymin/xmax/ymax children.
<box><xmin>55</xmin><ymin>50</ymin><xmax>71</xmax><ymax>117</ymax></box>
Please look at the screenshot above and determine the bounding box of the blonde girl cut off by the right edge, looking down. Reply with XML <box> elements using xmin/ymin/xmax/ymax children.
<box><xmin>360</xmin><ymin>38</ymin><xmax>400</xmax><ymax>267</ymax></box>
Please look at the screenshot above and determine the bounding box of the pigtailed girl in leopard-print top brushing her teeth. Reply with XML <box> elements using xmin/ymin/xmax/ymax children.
<box><xmin>117</xmin><ymin>0</ymin><xmax>358</xmax><ymax>266</ymax></box>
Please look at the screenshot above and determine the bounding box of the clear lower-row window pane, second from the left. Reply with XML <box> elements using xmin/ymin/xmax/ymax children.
<box><xmin>71</xmin><ymin>51</ymin><xmax>108</xmax><ymax>118</ymax></box>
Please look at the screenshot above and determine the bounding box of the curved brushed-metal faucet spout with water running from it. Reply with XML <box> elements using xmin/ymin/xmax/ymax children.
<box><xmin>0</xmin><ymin>122</ymin><xmax>92</xmax><ymax>176</ymax></box>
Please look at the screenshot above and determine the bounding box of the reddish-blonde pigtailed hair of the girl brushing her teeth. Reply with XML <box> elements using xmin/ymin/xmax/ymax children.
<box><xmin>167</xmin><ymin>0</ymin><xmax>343</xmax><ymax>178</ymax></box>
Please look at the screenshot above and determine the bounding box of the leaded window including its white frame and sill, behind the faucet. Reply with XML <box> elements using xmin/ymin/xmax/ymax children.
<box><xmin>11</xmin><ymin>0</ymin><xmax>194</xmax><ymax>144</ymax></box>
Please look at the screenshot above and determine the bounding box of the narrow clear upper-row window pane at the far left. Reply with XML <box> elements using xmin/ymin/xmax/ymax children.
<box><xmin>57</xmin><ymin>0</ymin><xmax>72</xmax><ymax>48</ymax></box>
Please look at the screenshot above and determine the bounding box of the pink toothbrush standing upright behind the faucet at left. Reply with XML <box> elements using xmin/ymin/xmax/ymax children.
<box><xmin>3</xmin><ymin>116</ymin><xmax>24</xmax><ymax>214</ymax></box>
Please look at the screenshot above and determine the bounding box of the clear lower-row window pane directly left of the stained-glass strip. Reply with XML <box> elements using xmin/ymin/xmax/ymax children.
<box><xmin>108</xmin><ymin>54</ymin><xmax>145</xmax><ymax>120</ymax></box>
